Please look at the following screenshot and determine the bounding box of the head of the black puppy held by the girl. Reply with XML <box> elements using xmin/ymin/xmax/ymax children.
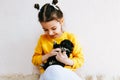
<box><xmin>53</xmin><ymin>39</ymin><xmax>74</xmax><ymax>56</ymax></box>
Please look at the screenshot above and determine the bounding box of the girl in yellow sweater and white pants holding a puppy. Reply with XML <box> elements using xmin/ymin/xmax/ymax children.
<box><xmin>32</xmin><ymin>0</ymin><xmax>84</xmax><ymax>80</ymax></box>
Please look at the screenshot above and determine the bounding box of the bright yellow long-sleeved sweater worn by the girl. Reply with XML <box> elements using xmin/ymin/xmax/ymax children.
<box><xmin>32</xmin><ymin>32</ymin><xmax>84</xmax><ymax>73</ymax></box>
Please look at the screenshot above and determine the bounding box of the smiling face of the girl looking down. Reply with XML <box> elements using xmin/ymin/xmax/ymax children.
<box><xmin>41</xmin><ymin>20</ymin><xmax>63</xmax><ymax>38</ymax></box>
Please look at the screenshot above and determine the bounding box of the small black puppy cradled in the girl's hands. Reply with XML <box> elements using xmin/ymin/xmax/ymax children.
<box><xmin>42</xmin><ymin>39</ymin><xmax>74</xmax><ymax>69</ymax></box>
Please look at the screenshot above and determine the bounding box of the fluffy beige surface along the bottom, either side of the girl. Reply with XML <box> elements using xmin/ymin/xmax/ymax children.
<box><xmin>0</xmin><ymin>73</ymin><xmax>120</xmax><ymax>80</ymax></box>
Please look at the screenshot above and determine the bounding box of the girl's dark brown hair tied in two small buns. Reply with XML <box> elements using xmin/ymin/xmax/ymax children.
<box><xmin>34</xmin><ymin>0</ymin><xmax>63</xmax><ymax>22</ymax></box>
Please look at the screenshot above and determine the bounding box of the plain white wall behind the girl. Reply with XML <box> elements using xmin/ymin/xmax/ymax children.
<box><xmin>0</xmin><ymin>0</ymin><xmax>120</xmax><ymax>74</ymax></box>
